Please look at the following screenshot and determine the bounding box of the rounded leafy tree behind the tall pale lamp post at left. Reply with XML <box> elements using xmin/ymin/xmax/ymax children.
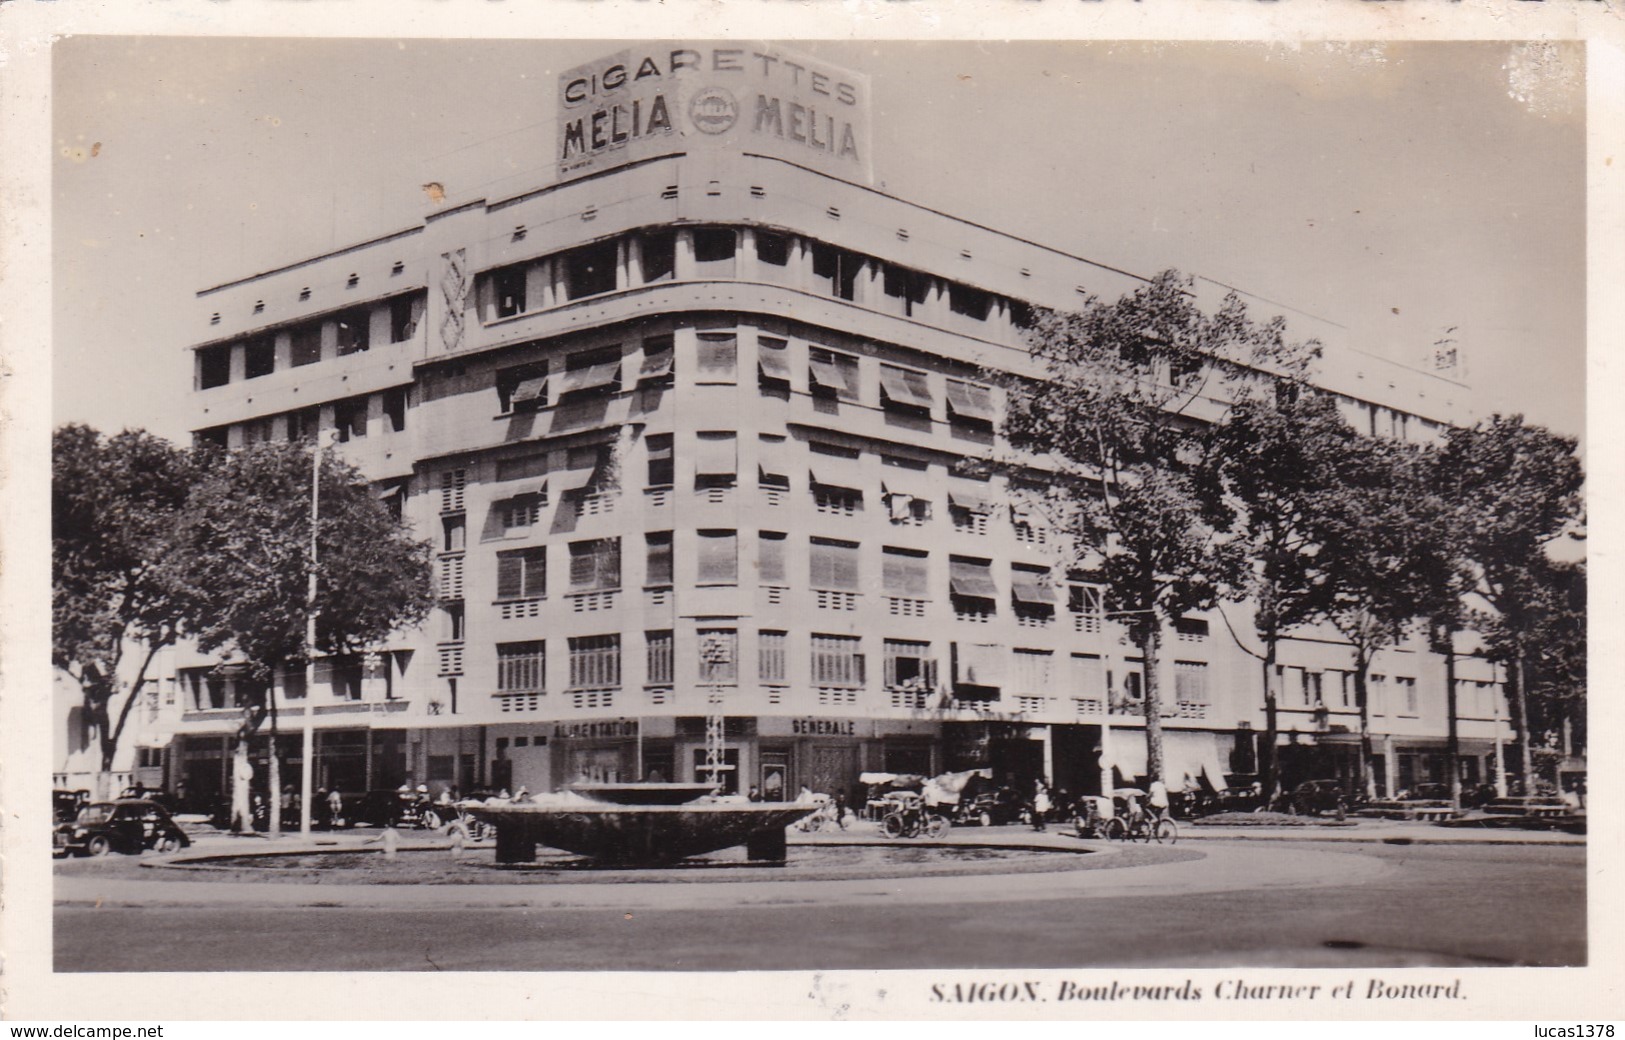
<box><xmin>180</xmin><ymin>444</ymin><xmax>432</xmax><ymax>827</ymax></box>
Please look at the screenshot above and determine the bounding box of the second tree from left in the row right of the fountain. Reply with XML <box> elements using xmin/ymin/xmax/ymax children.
<box><xmin>1209</xmin><ymin>390</ymin><xmax>1357</xmax><ymax>804</ymax></box>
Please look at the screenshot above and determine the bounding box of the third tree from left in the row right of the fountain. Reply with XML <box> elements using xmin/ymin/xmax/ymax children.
<box><xmin>1311</xmin><ymin>437</ymin><xmax>1451</xmax><ymax>798</ymax></box>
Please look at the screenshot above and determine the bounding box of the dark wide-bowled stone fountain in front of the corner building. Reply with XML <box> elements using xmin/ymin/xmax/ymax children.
<box><xmin>466</xmin><ymin>783</ymin><xmax>817</xmax><ymax>866</ymax></box>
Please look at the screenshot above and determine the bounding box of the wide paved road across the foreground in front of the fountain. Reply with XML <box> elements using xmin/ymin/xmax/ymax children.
<box><xmin>55</xmin><ymin>842</ymin><xmax>1586</xmax><ymax>972</ymax></box>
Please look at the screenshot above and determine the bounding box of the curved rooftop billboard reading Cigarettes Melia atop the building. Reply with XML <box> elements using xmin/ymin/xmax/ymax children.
<box><xmin>557</xmin><ymin>44</ymin><xmax>871</xmax><ymax>184</ymax></box>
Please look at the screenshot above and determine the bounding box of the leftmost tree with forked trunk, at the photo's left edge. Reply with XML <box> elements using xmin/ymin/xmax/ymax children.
<box><xmin>50</xmin><ymin>424</ymin><xmax>197</xmax><ymax>798</ymax></box>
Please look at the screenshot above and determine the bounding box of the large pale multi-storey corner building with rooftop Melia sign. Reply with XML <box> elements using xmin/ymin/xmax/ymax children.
<box><xmin>169</xmin><ymin>47</ymin><xmax>1508</xmax><ymax>809</ymax></box>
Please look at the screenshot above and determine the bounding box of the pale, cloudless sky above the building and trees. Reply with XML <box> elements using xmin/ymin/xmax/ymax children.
<box><xmin>52</xmin><ymin>37</ymin><xmax>1586</xmax><ymax>439</ymax></box>
